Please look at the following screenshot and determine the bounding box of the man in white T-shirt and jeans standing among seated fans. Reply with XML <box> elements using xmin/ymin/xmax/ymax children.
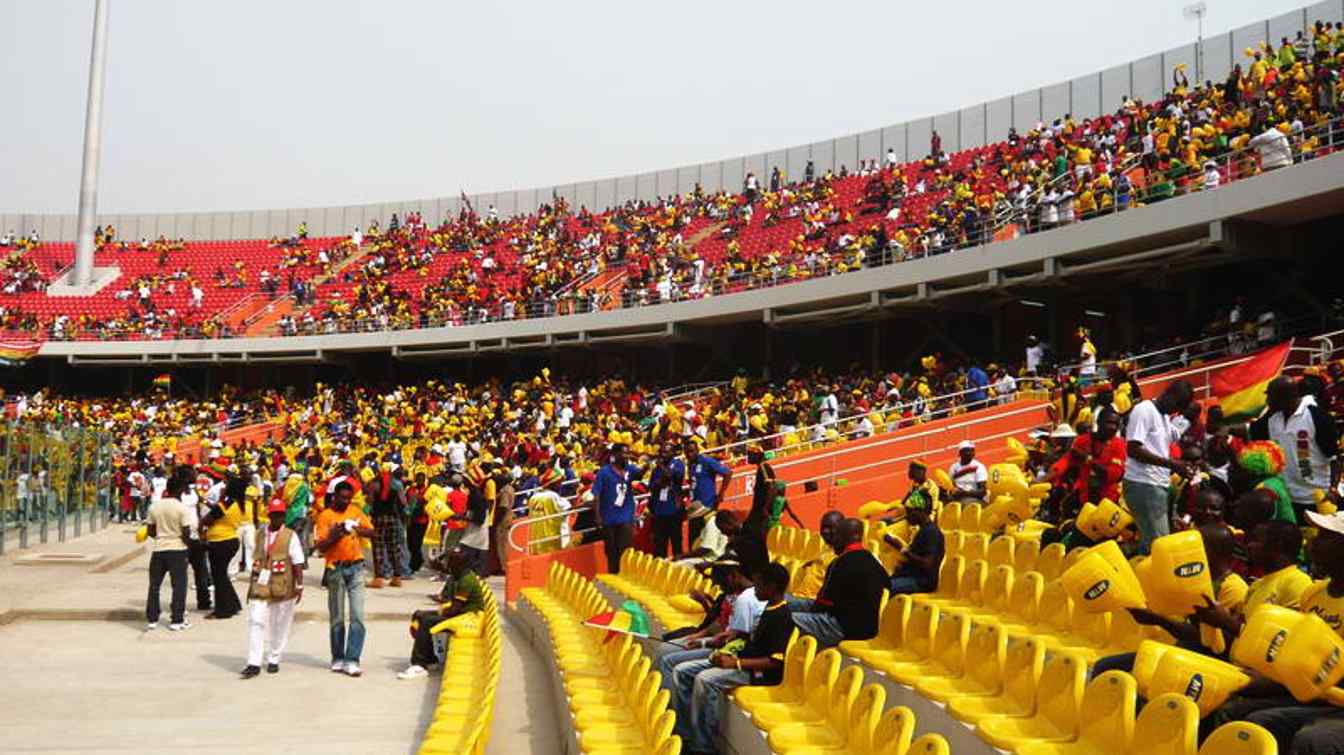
<box><xmin>1124</xmin><ymin>380</ymin><xmax>1195</xmax><ymax>555</ymax></box>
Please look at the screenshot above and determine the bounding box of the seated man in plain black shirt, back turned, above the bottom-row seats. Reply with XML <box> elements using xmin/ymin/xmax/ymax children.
<box><xmin>793</xmin><ymin>519</ymin><xmax>890</xmax><ymax>648</ymax></box>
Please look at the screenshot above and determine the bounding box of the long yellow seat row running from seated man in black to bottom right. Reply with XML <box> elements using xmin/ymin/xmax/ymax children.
<box><xmin>840</xmin><ymin>595</ymin><xmax>1275</xmax><ymax>755</ymax></box>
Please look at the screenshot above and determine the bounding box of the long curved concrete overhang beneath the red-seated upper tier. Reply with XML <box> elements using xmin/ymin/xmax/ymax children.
<box><xmin>52</xmin><ymin>154</ymin><xmax>1344</xmax><ymax>365</ymax></box>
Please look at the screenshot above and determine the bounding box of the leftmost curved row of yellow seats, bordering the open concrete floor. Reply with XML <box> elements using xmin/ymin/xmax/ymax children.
<box><xmin>419</xmin><ymin>591</ymin><xmax>503</xmax><ymax>755</ymax></box>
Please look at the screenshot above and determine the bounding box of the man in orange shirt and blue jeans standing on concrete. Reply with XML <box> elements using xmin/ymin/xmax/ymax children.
<box><xmin>316</xmin><ymin>480</ymin><xmax>374</xmax><ymax>676</ymax></box>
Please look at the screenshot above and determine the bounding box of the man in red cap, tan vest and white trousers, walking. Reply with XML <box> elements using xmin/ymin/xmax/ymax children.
<box><xmin>242</xmin><ymin>496</ymin><xmax>304</xmax><ymax>678</ymax></box>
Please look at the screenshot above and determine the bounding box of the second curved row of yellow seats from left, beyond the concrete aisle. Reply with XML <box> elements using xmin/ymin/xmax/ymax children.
<box><xmin>523</xmin><ymin>563</ymin><xmax>681</xmax><ymax>755</ymax></box>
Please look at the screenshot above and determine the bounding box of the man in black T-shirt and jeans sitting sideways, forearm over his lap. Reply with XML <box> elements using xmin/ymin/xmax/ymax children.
<box><xmin>673</xmin><ymin>563</ymin><xmax>793</xmax><ymax>752</ymax></box>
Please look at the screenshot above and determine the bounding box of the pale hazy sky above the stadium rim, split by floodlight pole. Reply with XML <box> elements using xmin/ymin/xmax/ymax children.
<box><xmin>0</xmin><ymin>0</ymin><xmax>1301</xmax><ymax>214</ymax></box>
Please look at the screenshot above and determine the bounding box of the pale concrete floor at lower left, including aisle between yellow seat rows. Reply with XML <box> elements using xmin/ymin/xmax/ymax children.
<box><xmin>0</xmin><ymin>525</ymin><xmax>560</xmax><ymax>755</ymax></box>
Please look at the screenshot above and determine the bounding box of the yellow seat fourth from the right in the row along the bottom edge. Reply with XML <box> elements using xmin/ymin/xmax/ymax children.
<box><xmin>976</xmin><ymin>652</ymin><xmax>1091</xmax><ymax>752</ymax></box>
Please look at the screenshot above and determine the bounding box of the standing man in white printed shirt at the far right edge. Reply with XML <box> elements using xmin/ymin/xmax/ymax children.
<box><xmin>1250</xmin><ymin>376</ymin><xmax>1340</xmax><ymax>523</ymax></box>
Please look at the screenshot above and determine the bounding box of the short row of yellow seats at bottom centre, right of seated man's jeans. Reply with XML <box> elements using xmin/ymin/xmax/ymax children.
<box><xmin>732</xmin><ymin>635</ymin><xmax>949</xmax><ymax>755</ymax></box>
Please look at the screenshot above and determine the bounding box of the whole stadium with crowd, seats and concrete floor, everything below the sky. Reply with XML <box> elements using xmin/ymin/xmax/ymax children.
<box><xmin>0</xmin><ymin>0</ymin><xmax>1344</xmax><ymax>755</ymax></box>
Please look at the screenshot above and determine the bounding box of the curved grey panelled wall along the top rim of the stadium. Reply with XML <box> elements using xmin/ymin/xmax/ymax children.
<box><xmin>0</xmin><ymin>0</ymin><xmax>1344</xmax><ymax>240</ymax></box>
